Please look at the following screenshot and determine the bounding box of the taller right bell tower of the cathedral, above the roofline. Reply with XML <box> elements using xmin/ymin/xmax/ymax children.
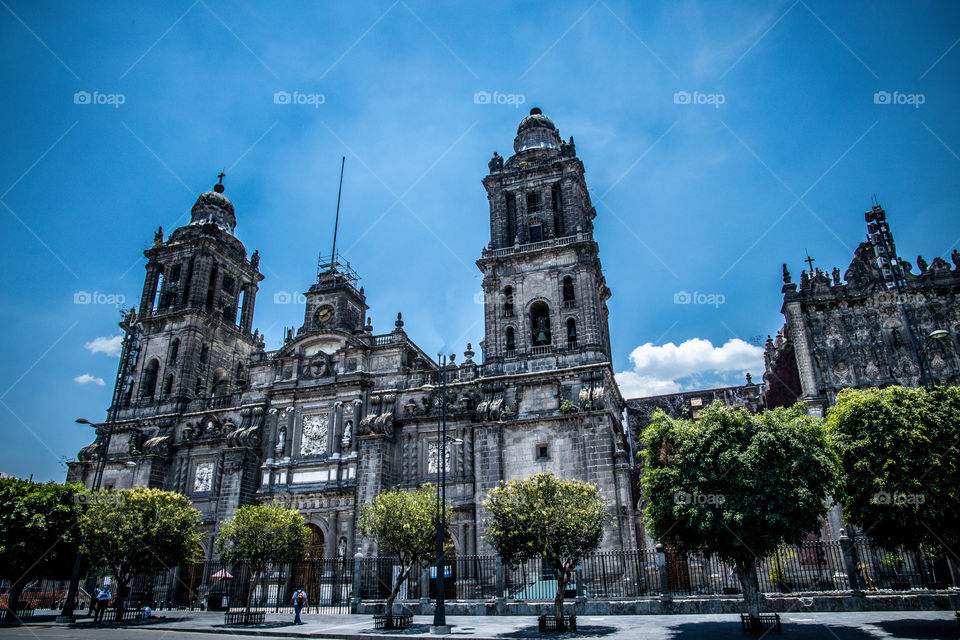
<box><xmin>477</xmin><ymin>108</ymin><xmax>610</xmax><ymax>373</ymax></box>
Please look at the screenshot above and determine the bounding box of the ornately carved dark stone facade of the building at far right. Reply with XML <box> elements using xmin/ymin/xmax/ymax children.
<box><xmin>764</xmin><ymin>206</ymin><xmax>960</xmax><ymax>416</ymax></box>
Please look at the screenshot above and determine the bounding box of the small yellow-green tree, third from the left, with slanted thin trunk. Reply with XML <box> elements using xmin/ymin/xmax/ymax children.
<box><xmin>217</xmin><ymin>505</ymin><xmax>310</xmax><ymax>613</ymax></box>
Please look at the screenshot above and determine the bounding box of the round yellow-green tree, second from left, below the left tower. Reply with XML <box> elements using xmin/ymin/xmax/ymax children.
<box><xmin>80</xmin><ymin>487</ymin><xmax>202</xmax><ymax>619</ymax></box>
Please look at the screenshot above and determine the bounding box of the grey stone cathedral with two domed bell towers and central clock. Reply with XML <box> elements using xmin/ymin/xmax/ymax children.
<box><xmin>68</xmin><ymin>108</ymin><xmax>642</xmax><ymax>558</ymax></box>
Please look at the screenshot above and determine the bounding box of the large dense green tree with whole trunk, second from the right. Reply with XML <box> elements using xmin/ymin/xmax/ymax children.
<box><xmin>641</xmin><ymin>402</ymin><xmax>836</xmax><ymax>618</ymax></box>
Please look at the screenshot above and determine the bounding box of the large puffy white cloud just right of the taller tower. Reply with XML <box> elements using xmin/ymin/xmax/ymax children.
<box><xmin>616</xmin><ymin>338</ymin><xmax>763</xmax><ymax>398</ymax></box>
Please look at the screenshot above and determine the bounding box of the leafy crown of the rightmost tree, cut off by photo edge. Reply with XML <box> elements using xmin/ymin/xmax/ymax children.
<box><xmin>827</xmin><ymin>387</ymin><xmax>960</xmax><ymax>551</ymax></box>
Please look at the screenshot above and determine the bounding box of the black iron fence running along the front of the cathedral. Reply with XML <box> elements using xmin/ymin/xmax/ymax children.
<box><xmin>0</xmin><ymin>538</ymin><xmax>957</xmax><ymax>613</ymax></box>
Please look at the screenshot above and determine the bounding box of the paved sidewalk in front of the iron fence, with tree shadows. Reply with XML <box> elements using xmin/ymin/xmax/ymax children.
<box><xmin>62</xmin><ymin>611</ymin><xmax>958</xmax><ymax>640</ymax></box>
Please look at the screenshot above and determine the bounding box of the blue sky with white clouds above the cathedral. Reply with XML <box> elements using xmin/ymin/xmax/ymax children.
<box><xmin>0</xmin><ymin>0</ymin><xmax>960</xmax><ymax>479</ymax></box>
